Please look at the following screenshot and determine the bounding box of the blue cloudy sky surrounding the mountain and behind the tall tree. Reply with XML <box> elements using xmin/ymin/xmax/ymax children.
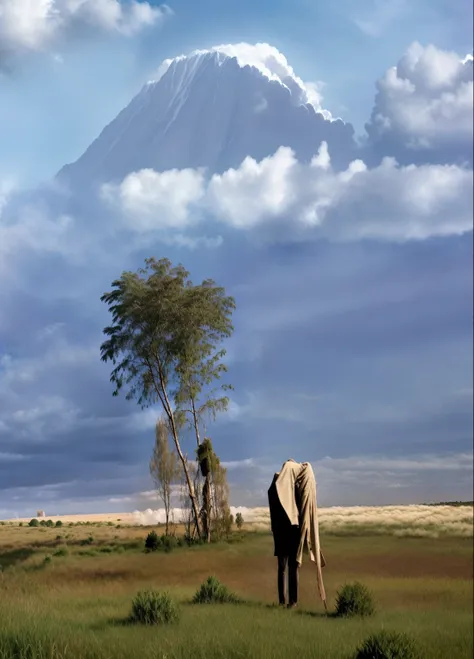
<box><xmin>0</xmin><ymin>0</ymin><xmax>472</xmax><ymax>517</ymax></box>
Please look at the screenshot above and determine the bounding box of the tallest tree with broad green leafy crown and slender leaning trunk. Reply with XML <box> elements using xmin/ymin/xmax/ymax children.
<box><xmin>100</xmin><ymin>258</ymin><xmax>235</xmax><ymax>536</ymax></box>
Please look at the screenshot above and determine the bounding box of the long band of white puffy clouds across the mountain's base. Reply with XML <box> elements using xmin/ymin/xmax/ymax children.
<box><xmin>103</xmin><ymin>142</ymin><xmax>472</xmax><ymax>241</ymax></box>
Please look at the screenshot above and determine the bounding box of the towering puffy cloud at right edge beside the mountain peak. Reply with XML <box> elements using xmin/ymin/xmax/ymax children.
<box><xmin>367</xmin><ymin>42</ymin><xmax>473</xmax><ymax>148</ymax></box>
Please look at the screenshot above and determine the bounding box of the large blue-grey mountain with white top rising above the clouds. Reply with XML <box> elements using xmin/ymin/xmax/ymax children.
<box><xmin>58</xmin><ymin>44</ymin><xmax>354</xmax><ymax>187</ymax></box>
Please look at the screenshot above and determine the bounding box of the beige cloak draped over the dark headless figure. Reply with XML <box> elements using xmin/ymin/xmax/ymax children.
<box><xmin>275</xmin><ymin>459</ymin><xmax>326</xmax><ymax>606</ymax></box>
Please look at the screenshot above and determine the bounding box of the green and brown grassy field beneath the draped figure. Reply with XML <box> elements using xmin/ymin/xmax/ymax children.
<box><xmin>0</xmin><ymin>521</ymin><xmax>473</xmax><ymax>659</ymax></box>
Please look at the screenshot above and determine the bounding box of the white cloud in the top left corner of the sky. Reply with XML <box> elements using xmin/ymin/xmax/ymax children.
<box><xmin>0</xmin><ymin>0</ymin><xmax>171</xmax><ymax>69</ymax></box>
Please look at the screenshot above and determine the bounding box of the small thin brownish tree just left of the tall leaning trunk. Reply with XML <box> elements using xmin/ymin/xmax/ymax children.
<box><xmin>150</xmin><ymin>418</ymin><xmax>179</xmax><ymax>535</ymax></box>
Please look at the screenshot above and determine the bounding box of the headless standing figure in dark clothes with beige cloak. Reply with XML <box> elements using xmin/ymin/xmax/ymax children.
<box><xmin>268</xmin><ymin>459</ymin><xmax>327</xmax><ymax>610</ymax></box>
